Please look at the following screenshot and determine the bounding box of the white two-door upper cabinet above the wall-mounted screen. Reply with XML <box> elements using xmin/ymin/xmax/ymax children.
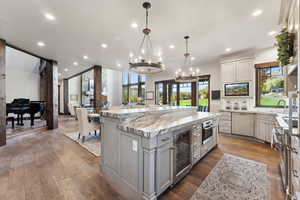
<box><xmin>221</xmin><ymin>59</ymin><xmax>254</xmax><ymax>83</ymax></box>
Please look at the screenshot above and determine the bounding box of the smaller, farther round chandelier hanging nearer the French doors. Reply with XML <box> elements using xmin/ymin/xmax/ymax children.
<box><xmin>175</xmin><ymin>36</ymin><xmax>199</xmax><ymax>83</ymax></box>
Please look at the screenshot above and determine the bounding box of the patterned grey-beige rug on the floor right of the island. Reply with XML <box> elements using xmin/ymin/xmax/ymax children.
<box><xmin>191</xmin><ymin>154</ymin><xmax>269</xmax><ymax>200</ymax></box>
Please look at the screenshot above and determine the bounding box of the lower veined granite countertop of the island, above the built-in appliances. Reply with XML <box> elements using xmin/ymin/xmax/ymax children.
<box><xmin>118</xmin><ymin>111</ymin><xmax>218</xmax><ymax>138</ymax></box>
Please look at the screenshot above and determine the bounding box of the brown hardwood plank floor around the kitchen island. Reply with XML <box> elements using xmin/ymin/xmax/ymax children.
<box><xmin>0</xmin><ymin>117</ymin><xmax>283</xmax><ymax>200</ymax></box>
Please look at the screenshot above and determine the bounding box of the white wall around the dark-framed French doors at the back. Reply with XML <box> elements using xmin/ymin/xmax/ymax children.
<box><xmin>146</xmin><ymin>61</ymin><xmax>221</xmax><ymax>112</ymax></box>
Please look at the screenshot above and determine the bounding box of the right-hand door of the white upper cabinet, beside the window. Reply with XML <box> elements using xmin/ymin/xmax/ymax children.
<box><xmin>236</xmin><ymin>60</ymin><xmax>254</xmax><ymax>81</ymax></box>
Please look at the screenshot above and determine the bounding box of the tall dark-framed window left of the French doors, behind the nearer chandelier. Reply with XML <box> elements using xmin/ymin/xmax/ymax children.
<box><xmin>123</xmin><ymin>72</ymin><xmax>146</xmax><ymax>104</ymax></box>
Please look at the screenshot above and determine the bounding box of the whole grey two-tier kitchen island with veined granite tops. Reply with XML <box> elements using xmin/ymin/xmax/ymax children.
<box><xmin>100</xmin><ymin>106</ymin><xmax>218</xmax><ymax>200</ymax></box>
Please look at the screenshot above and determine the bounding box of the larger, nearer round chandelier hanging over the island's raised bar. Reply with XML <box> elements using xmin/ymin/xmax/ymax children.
<box><xmin>129</xmin><ymin>2</ymin><xmax>163</xmax><ymax>74</ymax></box>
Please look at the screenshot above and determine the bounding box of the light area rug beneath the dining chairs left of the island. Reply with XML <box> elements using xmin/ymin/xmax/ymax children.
<box><xmin>64</xmin><ymin>132</ymin><xmax>101</xmax><ymax>156</ymax></box>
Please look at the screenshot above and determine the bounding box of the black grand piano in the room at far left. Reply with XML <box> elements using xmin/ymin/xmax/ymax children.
<box><xmin>6</xmin><ymin>98</ymin><xmax>46</xmax><ymax>126</ymax></box>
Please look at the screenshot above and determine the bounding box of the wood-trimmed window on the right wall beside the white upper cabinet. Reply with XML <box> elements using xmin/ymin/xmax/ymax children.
<box><xmin>255</xmin><ymin>62</ymin><xmax>286</xmax><ymax>107</ymax></box>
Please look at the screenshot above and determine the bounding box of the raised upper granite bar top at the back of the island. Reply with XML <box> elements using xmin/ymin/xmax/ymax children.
<box><xmin>100</xmin><ymin>106</ymin><xmax>197</xmax><ymax>119</ymax></box>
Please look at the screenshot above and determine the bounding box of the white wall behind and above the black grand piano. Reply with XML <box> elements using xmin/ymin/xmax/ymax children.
<box><xmin>5</xmin><ymin>47</ymin><xmax>40</xmax><ymax>103</ymax></box>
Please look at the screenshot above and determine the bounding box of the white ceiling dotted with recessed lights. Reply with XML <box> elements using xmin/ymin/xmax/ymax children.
<box><xmin>0</xmin><ymin>0</ymin><xmax>280</xmax><ymax>77</ymax></box>
